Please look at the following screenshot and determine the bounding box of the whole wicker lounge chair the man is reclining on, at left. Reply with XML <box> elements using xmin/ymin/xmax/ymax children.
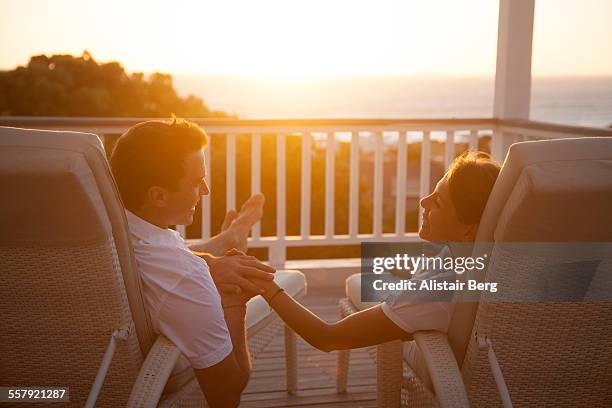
<box><xmin>0</xmin><ymin>127</ymin><xmax>306</xmax><ymax>407</ymax></box>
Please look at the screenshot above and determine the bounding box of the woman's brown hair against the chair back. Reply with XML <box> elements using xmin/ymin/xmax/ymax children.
<box><xmin>446</xmin><ymin>151</ymin><xmax>501</xmax><ymax>225</ymax></box>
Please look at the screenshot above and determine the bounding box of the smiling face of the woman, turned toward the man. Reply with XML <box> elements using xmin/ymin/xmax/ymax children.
<box><xmin>419</xmin><ymin>175</ymin><xmax>473</xmax><ymax>243</ymax></box>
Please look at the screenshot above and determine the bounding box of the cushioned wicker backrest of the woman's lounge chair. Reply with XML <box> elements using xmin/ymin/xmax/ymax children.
<box><xmin>455</xmin><ymin>138</ymin><xmax>612</xmax><ymax>406</ymax></box>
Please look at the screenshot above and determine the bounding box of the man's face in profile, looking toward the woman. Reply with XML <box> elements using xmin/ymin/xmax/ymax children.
<box><xmin>163</xmin><ymin>150</ymin><xmax>210</xmax><ymax>225</ymax></box>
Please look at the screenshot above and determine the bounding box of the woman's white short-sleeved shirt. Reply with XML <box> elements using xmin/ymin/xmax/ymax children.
<box><xmin>381</xmin><ymin>247</ymin><xmax>456</xmax><ymax>333</ymax></box>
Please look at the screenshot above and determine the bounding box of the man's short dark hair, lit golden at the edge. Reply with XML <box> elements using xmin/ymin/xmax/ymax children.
<box><xmin>110</xmin><ymin>117</ymin><xmax>208</xmax><ymax>210</ymax></box>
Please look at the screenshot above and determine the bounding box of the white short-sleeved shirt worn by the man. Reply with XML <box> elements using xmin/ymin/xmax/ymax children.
<box><xmin>126</xmin><ymin>210</ymin><xmax>232</xmax><ymax>368</ymax></box>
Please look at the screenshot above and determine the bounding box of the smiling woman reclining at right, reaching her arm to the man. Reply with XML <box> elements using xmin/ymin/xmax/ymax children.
<box><xmin>255</xmin><ymin>152</ymin><xmax>500</xmax><ymax>352</ymax></box>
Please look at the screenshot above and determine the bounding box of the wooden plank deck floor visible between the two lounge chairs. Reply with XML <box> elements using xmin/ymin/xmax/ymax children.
<box><xmin>240</xmin><ymin>289</ymin><xmax>376</xmax><ymax>408</ymax></box>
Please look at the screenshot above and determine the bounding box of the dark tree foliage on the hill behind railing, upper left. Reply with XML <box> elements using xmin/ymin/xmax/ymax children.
<box><xmin>0</xmin><ymin>51</ymin><xmax>228</xmax><ymax>118</ymax></box>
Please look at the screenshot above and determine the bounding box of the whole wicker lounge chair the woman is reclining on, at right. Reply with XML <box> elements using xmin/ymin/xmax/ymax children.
<box><xmin>338</xmin><ymin>138</ymin><xmax>612</xmax><ymax>407</ymax></box>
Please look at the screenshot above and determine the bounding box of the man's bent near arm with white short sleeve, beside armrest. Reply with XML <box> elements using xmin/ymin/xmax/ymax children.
<box><xmin>158</xmin><ymin>273</ymin><xmax>249</xmax><ymax>407</ymax></box>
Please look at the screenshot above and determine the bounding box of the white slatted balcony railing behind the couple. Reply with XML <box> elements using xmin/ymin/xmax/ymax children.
<box><xmin>0</xmin><ymin>118</ymin><xmax>612</xmax><ymax>265</ymax></box>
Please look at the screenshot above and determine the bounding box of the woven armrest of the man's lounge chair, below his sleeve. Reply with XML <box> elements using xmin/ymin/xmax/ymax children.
<box><xmin>128</xmin><ymin>335</ymin><xmax>181</xmax><ymax>408</ymax></box>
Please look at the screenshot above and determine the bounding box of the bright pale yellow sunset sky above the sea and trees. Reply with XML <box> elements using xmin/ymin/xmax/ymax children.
<box><xmin>0</xmin><ymin>0</ymin><xmax>612</xmax><ymax>78</ymax></box>
